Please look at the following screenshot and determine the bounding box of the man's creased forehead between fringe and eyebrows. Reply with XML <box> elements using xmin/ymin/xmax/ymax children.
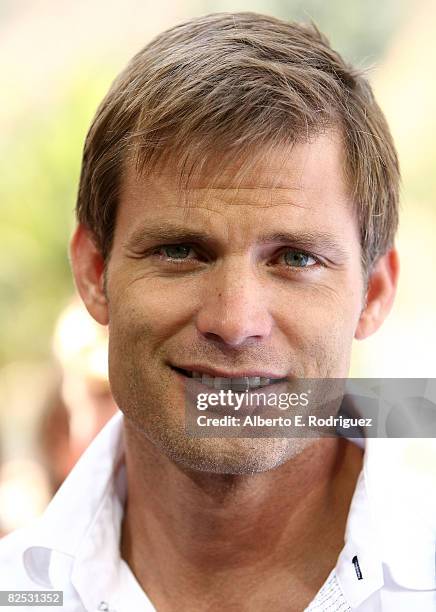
<box><xmin>115</xmin><ymin>132</ymin><xmax>354</xmax><ymax>241</ymax></box>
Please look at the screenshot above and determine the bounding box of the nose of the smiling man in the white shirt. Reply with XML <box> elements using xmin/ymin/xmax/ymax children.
<box><xmin>196</xmin><ymin>262</ymin><xmax>272</xmax><ymax>347</ymax></box>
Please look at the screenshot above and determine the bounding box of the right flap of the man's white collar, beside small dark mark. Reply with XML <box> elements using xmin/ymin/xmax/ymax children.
<box><xmin>336</xmin><ymin>438</ymin><xmax>436</xmax><ymax>607</ymax></box>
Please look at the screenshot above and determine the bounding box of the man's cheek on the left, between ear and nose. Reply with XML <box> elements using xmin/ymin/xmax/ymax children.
<box><xmin>109</xmin><ymin>278</ymin><xmax>200</xmax><ymax>414</ymax></box>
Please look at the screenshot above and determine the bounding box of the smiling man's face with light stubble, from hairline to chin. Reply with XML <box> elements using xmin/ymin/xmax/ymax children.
<box><xmin>107</xmin><ymin>134</ymin><xmax>364</xmax><ymax>473</ymax></box>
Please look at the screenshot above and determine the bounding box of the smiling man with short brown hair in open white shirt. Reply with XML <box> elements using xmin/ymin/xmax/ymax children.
<box><xmin>0</xmin><ymin>14</ymin><xmax>436</xmax><ymax>612</ymax></box>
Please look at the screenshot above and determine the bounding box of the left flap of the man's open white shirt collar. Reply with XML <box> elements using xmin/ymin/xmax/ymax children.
<box><xmin>23</xmin><ymin>411</ymin><xmax>125</xmax><ymax>609</ymax></box>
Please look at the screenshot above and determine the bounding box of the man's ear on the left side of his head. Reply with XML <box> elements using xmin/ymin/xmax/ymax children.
<box><xmin>70</xmin><ymin>224</ymin><xmax>109</xmax><ymax>325</ymax></box>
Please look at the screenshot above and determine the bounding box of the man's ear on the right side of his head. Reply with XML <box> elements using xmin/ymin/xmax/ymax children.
<box><xmin>354</xmin><ymin>249</ymin><xmax>400</xmax><ymax>340</ymax></box>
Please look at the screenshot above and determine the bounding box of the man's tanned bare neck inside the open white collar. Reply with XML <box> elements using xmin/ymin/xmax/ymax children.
<box><xmin>121</xmin><ymin>423</ymin><xmax>362</xmax><ymax>611</ymax></box>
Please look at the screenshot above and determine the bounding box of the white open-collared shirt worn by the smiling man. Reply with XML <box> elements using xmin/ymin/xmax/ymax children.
<box><xmin>0</xmin><ymin>412</ymin><xmax>436</xmax><ymax>612</ymax></box>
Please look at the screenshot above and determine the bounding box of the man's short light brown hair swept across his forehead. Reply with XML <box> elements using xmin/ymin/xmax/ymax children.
<box><xmin>77</xmin><ymin>13</ymin><xmax>399</xmax><ymax>270</ymax></box>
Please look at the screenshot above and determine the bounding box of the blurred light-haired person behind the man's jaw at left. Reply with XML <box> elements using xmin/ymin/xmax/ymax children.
<box><xmin>38</xmin><ymin>299</ymin><xmax>117</xmax><ymax>493</ymax></box>
